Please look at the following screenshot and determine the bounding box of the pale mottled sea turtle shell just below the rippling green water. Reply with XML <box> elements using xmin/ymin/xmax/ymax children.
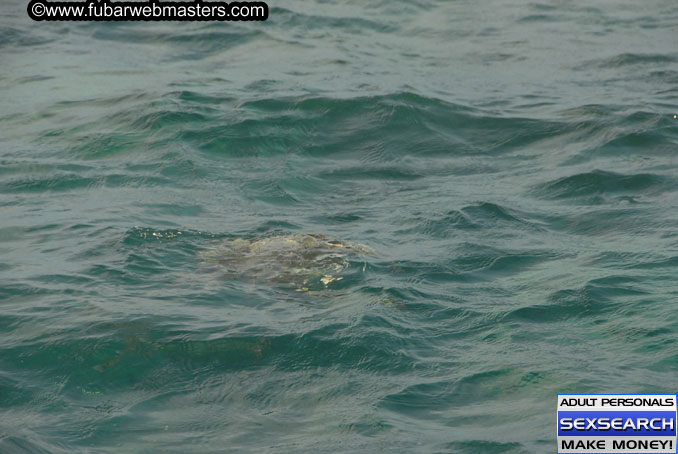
<box><xmin>199</xmin><ymin>233</ymin><xmax>375</xmax><ymax>291</ymax></box>
